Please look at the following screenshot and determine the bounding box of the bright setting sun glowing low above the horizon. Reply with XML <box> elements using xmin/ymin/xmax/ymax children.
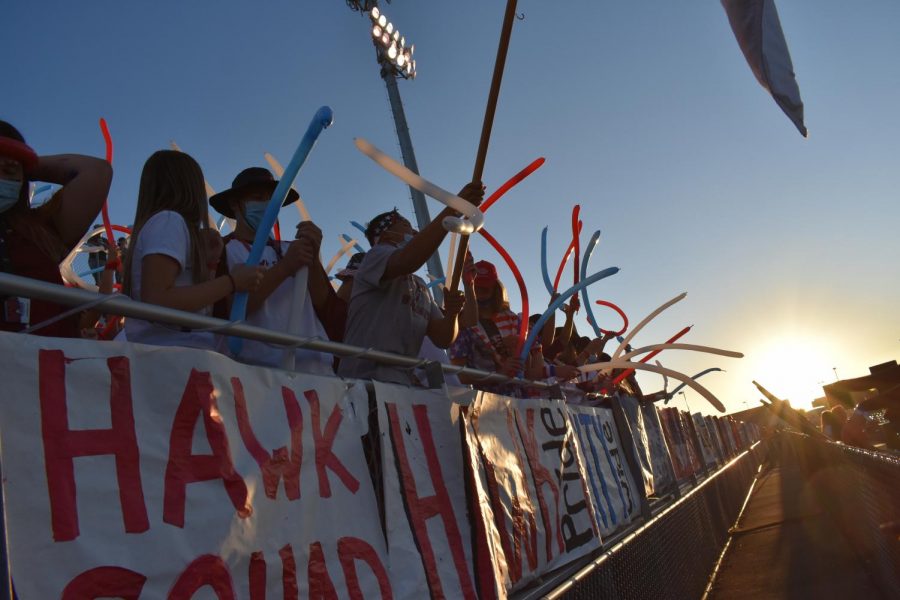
<box><xmin>748</xmin><ymin>336</ymin><xmax>834</xmax><ymax>408</ymax></box>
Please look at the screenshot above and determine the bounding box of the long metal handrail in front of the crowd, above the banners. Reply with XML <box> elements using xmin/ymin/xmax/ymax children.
<box><xmin>0</xmin><ymin>273</ymin><xmax>555</xmax><ymax>389</ymax></box>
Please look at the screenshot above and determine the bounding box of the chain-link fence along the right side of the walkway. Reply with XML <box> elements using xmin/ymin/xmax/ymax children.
<box><xmin>773</xmin><ymin>433</ymin><xmax>900</xmax><ymax>598</ymax></box>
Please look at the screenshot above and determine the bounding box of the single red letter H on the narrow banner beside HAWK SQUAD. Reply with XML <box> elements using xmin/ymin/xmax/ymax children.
<box><xmin>385</xmin><ymin>402</ymin><xmax>476</xmax><ymax>598</ymax></box>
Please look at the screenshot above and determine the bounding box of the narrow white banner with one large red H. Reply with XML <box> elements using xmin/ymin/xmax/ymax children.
<box><xmin>375</xmin><ymin>382</ymin><xmax>488</xmax><ymax>598</ymax></box>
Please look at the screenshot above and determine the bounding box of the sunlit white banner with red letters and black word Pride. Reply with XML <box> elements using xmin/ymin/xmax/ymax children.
<box><xmin>467</xmin><ymin>392</ymin><xmax>600</xmax><ymax>590</ymax></box>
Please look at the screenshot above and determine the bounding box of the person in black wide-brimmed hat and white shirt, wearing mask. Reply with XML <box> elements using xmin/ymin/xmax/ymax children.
<box><xmin>209</xmin><ymin>167</ymin><xmax>335</xmax><ymax>374</ymax></box>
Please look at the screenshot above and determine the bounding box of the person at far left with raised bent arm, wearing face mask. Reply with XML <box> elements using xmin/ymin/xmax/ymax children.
<box><xmin>0</xmin><ymin>121</ymin><xmax>112</xmax><ymax>337</ymax></box>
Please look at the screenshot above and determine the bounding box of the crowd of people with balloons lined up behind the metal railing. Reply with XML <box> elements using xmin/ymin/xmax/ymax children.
<box><xmin>0</xmin><ymin>121</ymin><xmax>656</xmax><ymax>396</ymax></box>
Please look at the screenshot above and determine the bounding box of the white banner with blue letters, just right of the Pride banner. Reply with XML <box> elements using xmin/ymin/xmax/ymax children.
<box><xmin>568</xmin><ymin>405</ymin><xmax>641</xmax><ymax>536</ymax></box>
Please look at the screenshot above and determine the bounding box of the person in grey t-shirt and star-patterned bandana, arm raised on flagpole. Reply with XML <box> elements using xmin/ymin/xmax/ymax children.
<box><xmin>338</xmin><ymin>182</ymin><xmax>484</xmax><ymax>385</ymax></box>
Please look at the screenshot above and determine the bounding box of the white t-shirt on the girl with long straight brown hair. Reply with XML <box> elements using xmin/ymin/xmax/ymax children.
<box><xmin>125</xmin><ymin>210</ymin><xmax>221</xmax><ymax>350</ymax></box>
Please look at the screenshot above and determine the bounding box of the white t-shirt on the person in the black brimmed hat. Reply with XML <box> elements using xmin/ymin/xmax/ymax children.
<box><xmin>225</xmin><ymin>239</ymin><xmax>334</xmax><ymax>375</ymax></box>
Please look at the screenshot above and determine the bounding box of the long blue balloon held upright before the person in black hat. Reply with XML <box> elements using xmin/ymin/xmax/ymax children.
<box><xmin>228</xmin><ymin>106</ymin><xmax>334</xmax><ymax>355</ymax></box>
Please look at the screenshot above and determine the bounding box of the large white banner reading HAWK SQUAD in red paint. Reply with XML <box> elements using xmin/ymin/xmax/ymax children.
<box><xmin>0</xmin><ymin>333</ymin><xmax>392</xmax><ymax>600</ymax></box>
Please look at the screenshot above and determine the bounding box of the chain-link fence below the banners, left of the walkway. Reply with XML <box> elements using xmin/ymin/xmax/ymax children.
<box><xmin>532</xmin><ymin>444</ymin><xmax>763</xmax><ymax>600</ymax></box>
